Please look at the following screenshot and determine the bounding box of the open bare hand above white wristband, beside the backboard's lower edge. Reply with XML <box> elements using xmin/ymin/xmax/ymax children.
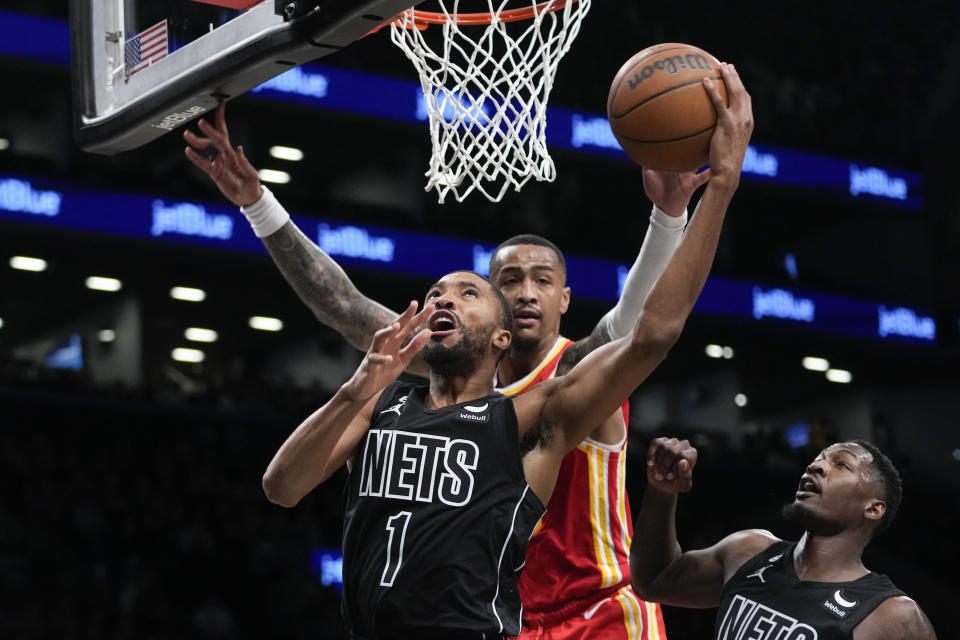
<box><xmin>183</xmin><ymin>104</ymin><xmax>263</xmax><ymax>207</ymax></box>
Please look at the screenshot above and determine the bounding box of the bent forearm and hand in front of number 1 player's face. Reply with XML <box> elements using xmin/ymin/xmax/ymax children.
<box><xmin>263</xmin><ymin>302</ymin><xmax>430</xmax><ymax>507</ymax></box>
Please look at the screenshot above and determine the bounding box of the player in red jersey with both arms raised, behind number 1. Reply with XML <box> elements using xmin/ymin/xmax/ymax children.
<box><xmin>185</xmin><ymin>77</ymin><xmax>728</xmax><ymax>640</ymax></box>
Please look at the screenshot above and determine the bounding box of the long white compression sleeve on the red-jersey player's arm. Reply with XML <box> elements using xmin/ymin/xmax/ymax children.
<box><xmin>600</xmin><ymin>206</ymin><xmax>687</xmax><ymax>340</ymax></box>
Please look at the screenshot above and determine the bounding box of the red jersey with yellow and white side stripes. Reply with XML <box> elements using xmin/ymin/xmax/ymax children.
<box><xmin>497</xmin><ymin>336</ymin><xmax>666</xmax><ymax>640</ymax></box>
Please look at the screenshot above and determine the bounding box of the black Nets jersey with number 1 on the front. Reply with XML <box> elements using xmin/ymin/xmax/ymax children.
<box><xmin>343</xmin><ymin>382</ymin><xmax>545</xmax><ymax>640</ymax></box>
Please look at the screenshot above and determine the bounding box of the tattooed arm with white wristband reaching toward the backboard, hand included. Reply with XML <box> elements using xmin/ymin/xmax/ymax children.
<box><xmin>183</xmin><ymin>105</ymin><xmax>428</xmax><ymax>375</ymax></box>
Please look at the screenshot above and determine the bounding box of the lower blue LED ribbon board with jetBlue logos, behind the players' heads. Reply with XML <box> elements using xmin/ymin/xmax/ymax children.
<box><xmin>0</xmin><ymin>170</ymin><xmax>937</xmax><ymax>344</ymax></box>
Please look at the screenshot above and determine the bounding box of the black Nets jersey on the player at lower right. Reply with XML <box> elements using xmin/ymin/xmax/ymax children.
<box><xmin>716</xmin><ymin>541</ymin><xmax>903</xmax><ymax>640</ymax></box>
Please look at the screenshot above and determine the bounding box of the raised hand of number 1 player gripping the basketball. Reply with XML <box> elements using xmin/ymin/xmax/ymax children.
<box><xmin>703</xmin><ymin>62</ymin><xmax>753</xmax><ymax>187</ymax></box>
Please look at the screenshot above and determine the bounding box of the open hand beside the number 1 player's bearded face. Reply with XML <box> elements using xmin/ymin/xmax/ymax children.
<box><xmin>343</xmin><ymin>300</ymin><xmax>431</xmax><ymax>400</ymax></box>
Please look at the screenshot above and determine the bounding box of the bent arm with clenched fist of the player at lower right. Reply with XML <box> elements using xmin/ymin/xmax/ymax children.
<box><xmin>630</xmin><ymin>438</ymin><xmax>776</xmax><ymax>608</ymax></box>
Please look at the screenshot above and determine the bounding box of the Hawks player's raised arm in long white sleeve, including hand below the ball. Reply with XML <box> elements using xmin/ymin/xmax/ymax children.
<box><xmin>557</xmin><ymin>168</ymin><xmax>710</xmax><ymax>375</ymax></box>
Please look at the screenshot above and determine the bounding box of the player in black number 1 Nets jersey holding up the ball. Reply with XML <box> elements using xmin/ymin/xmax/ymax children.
<box><xmin>263</xmin><ymin>66</ymin><xmax>753</xmax><ymax>640</ymax></box>
